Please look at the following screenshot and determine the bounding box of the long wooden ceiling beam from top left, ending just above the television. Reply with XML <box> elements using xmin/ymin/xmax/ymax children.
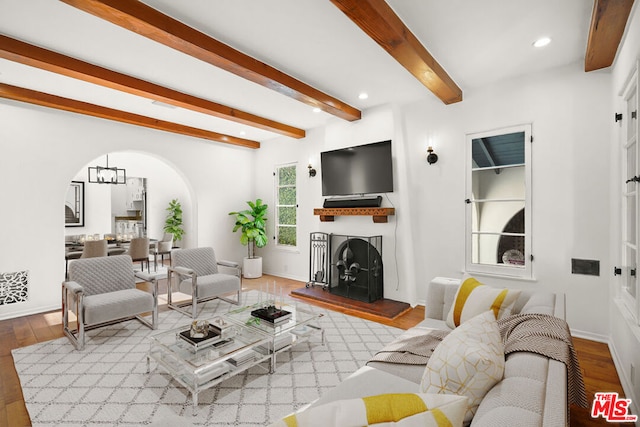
<box><xmin>61</xmin><ymin>0</ymin><xmax>362</xmax><ymax>121</ymax></box>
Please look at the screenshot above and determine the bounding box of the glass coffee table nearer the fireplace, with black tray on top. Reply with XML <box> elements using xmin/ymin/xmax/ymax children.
<box><xmin>222</xmin><ymin>295</ymin><xmax>325</xmax><ymax>372</ymax></box>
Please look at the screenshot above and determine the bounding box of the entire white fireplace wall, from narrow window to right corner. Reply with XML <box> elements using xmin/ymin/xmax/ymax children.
<box><xmin>256</xmin><ymin>64</ymin><xmax>611</xmax><ymax>340</ymax></box>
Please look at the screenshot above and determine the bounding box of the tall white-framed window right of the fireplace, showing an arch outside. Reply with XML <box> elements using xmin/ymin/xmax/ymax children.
<box><xmin>466</xmin><ymin>125</ymin><xmax>532</xmax><ymax>278</ymax></box>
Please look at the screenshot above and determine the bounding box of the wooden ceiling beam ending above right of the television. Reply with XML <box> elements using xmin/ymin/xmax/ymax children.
<box><xmin>331</xmin><ymin>0</ymin><xmax>462</xmax><ymax>104</ymax></box>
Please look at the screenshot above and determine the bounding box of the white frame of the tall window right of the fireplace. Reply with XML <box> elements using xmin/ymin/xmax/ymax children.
<box><xmin>465</xmin><ymin>123</ymin><xmax>534</xmax><ymax>280</ymax></box>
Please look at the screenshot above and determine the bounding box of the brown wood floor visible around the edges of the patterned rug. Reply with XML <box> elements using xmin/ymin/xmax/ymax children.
<box><xmin>0</xmin><ymin>275</ymin><xmax>629</xmax><ymax>427</ymax></box>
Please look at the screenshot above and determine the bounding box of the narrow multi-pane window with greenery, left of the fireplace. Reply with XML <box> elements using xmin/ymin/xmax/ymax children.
<box><xmin>275</xmin><ymin>164</ymin><xmax>298</xmax><ymax>251</ymax></box>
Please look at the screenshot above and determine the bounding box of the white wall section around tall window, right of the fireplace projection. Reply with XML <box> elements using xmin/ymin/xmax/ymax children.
<box><xmin>403</xmin><ymin>64</ymin><xmax>611</xmax><ymax>339</ymax></box>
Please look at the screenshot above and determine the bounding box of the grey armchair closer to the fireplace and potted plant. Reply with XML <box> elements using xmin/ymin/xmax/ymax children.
<box><xmin>167</xmin><ymin>248</ymin><xmax>242</xmax><ymax>319</ymax></box>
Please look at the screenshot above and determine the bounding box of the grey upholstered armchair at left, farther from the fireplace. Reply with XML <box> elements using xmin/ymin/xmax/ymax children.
<box><xmin>62</xmin><ymin>255</ymin><xmax>158</xmax><ymax>350</ymax></box>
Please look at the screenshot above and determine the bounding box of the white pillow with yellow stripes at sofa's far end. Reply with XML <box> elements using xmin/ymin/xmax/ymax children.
<box><xmin>446</xmin><ymin>277</ymin><xmax>520</xmax><ymax>329</ymax></box>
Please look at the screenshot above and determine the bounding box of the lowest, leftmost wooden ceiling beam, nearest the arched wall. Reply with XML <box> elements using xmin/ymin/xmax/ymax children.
<box><xmin>0</xmin><ymin>83</ymin><xmax>260</xmax><ymax>148</ymax></box>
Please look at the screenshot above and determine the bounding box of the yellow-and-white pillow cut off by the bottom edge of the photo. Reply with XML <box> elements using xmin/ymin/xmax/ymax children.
<box><xmin>269</xmin><ymin>393</ymin><xmax>467</xmax><ymax>427</ymax></box>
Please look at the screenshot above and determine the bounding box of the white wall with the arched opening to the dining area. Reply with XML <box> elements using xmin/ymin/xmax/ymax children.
<box><xmin>0</xmin><ymin>100</ymin><xmax>255</xmax><ymax>318</ymax></box>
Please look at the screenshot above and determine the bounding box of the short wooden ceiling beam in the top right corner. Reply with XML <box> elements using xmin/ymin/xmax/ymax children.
<box><xmin>584</xmin><ymin>0</ymin><xmax>633</xmax><ymax>71</ymax></box>
